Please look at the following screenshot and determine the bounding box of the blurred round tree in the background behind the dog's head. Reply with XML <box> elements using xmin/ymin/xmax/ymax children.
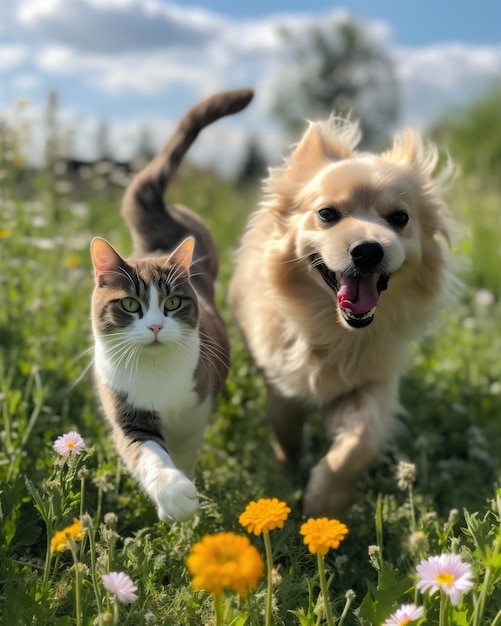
<box><xmin>274</xmin><ymin>20</ymin><xmax>399</xmax><ymax>147</ymax></box>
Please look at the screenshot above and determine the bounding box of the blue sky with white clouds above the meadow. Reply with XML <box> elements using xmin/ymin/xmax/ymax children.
<box><xmin>0</xmin><ymin>0</ymin><xmax>501</xmax><ymax>171</ymax></box>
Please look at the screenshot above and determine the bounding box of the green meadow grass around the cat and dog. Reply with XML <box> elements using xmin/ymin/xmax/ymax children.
<box><xmin>0</xmin><ymin>118</ymin><xmax>501</xmax><ymax>626</ymax></box>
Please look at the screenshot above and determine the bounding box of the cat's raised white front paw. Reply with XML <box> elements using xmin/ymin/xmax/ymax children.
<box><xmin>154</xmin><ymin>470</ymin><xmax>198</xmax><ymax>523</ymax></box>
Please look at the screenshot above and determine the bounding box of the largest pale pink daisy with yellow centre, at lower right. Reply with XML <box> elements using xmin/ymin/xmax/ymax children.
<box><xmin>416</xmin><ymin>554</ymin><xmax>473</xmax><ymax>606</ymax></box>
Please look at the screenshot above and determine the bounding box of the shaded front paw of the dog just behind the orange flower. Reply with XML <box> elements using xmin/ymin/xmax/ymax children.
<box><xmin>303</xmin><ymin>459</ymin><xmax>354</xmax><ymax>519</ymax></box>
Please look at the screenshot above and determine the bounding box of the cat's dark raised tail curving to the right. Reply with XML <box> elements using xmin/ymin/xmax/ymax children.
<box><xmin>122</xmin><ymin>89</ymin><xmax>254</xmax><ymax>241</ymax></box>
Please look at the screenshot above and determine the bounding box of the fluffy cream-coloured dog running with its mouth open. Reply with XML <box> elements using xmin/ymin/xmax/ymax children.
<box><xmin>229</xmin><ymin>116</ymin><xmax>453</xmax><ymax>517</ymax></box>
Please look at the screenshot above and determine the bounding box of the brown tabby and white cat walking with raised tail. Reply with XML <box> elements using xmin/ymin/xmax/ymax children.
<box><xmin>91</xmin><ymin>89</ymin><xmax>253</xmax><ymax>523</ymax></box>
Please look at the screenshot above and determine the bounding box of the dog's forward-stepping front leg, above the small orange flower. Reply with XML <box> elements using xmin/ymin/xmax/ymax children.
<box><xmin>304</xmin><ymin>380</ymin><xmax>399</xmax><ymax>518</ymax></box>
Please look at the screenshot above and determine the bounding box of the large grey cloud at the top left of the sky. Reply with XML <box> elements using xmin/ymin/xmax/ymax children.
<box><xmin>0</xmin><ymin>0</ymin><xmax>225</xmax><ymax>54</ymax></box>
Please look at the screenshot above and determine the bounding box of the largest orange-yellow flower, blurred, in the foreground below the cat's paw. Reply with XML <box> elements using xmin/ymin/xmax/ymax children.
<box><xmin>186</xmin><ymin>533</ymin><xmax>264</xmax><ymax>598</ymax></box>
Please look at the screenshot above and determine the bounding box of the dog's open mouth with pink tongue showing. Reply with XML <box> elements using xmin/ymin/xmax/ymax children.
<box><xmin>312</xmin><ymin>256</ymin><xmax>390</xmax><ymax>328</ymax></box>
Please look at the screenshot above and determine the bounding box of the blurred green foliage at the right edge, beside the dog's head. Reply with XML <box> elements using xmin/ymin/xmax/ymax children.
<box><xmin>434</xmin><ymin>82</ymin><xmax>501</xmax><ymax>189</ymax></box>
